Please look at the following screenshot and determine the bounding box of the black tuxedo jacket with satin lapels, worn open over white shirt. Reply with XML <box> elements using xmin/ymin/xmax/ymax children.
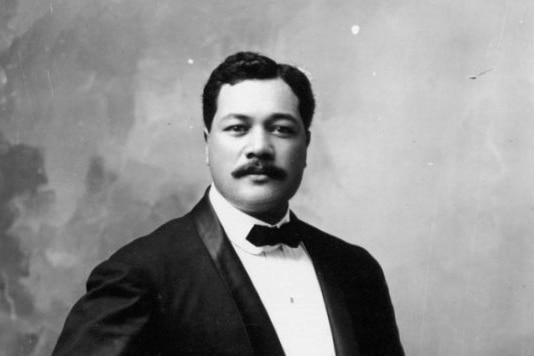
<box><xmin>53</xmin><ymin>195</ymin><xmax>404</xmax><ymax>356</ymax></box>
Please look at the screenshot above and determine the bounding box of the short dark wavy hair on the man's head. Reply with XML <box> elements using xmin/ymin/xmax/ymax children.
<box><xmin>202</xmin><ymin>52</ymin><xmax>315</xmax><ymax>131</ymax></box>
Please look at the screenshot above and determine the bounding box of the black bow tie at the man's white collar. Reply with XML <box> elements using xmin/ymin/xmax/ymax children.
<box><xmin>247</xmin><ymin>222</ymin><xmax>301</xmax><ymax>248</ymax></box>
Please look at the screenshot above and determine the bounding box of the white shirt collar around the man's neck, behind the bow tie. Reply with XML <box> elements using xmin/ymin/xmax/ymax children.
<box><xmin>209</xmin><ymin>184</ymin><xmax>289</xmax><ymax>255</ymax></box>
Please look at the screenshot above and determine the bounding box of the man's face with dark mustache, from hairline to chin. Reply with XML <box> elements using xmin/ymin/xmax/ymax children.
<box><xmin>205</xmin><ymin>78</ymin><xmax>309</xmax><ymax>216</ymax></box>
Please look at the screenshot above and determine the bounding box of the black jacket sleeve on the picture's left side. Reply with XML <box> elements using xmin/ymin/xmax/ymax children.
<box><xmin>52</xmin><ymin>260</ymin><xmax>157</xmax><ymax>356</ymax></box>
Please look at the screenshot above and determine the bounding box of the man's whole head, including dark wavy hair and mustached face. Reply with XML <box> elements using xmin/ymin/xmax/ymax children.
<box><xmin>203</xmin><ymin>52</ymin><xmax>315</xmax><ymax>221</ymax></box>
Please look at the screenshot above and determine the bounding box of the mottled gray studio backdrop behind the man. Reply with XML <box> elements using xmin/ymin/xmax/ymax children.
<box><xmin>0</xmin><ymin>0</ymin><xmax>534</xmax><ymax>356</ymax></box>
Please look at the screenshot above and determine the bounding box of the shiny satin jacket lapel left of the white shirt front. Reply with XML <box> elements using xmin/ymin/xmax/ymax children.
<box><xmin>192</xmin><ymin>192</ymin><xmax>284</xmax><ymax>356</ymax></box>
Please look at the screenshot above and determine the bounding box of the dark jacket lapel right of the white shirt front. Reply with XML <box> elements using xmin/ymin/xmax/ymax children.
<box><xmin>291</xmin><ymin>215</ymin><xmax>360</xmax><ymax>356</ymax></box>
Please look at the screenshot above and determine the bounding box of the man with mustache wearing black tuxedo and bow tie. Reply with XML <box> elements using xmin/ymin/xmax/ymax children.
<box><xmin>54</xmin><ymin>52</ymin><xmax>403</xmax><ymax>356</ymax></box>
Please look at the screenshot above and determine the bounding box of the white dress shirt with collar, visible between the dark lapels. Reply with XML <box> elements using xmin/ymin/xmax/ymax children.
<box><xmin>209</xmin><ymin>184</ymin><xmax>335</xmax><ymax>356</ymax></box>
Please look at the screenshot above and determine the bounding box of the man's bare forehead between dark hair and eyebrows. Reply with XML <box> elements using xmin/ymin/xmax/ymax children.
<box><xmin>215</xmin><ymin>78</ymin><xmax>300</xmax><ymax>119</ymax></box>
